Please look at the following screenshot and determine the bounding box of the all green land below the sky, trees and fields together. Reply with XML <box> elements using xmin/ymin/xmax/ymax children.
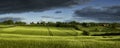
<box><xmin>0</xmin><ymin>20</ymin><xmax>120</xmax><ymax>48</ymax></box>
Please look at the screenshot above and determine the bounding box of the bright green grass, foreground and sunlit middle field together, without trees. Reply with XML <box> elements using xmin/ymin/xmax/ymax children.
<box><xmin>0</xmin><ymin>25</ymin><xmax>120</xmax><ymax>48</ymax></box>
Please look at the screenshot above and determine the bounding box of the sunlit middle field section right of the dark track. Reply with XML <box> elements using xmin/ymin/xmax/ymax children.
<box><xmin>50</xmin><ymin>27</ymin><xmax>81</xmax><ymax>36</ymax></box>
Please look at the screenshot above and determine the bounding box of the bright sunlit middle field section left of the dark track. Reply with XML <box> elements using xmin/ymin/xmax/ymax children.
<box><xmin>0</xmin><ymin>26</ymin><xmax>49</xmax><ymax>35</ymax></box>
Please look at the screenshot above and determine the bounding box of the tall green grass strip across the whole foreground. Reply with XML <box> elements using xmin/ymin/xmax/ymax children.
<box><xmin>0</xmin><ymin>34</ymin><xmax>120</xmax><ymax>48</ymax></box>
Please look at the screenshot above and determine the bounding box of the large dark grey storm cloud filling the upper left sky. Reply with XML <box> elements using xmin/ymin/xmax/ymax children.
<box><xmin>0</xmin><ymin>0</ymin><xmax>89</xmax><ymax>14</ymax></box>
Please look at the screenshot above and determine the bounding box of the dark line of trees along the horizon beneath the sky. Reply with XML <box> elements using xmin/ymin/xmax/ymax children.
<box><xmin>0</xmin><ymin>20</ymin><xmax>120</xmax><ymax>29</ymax></box>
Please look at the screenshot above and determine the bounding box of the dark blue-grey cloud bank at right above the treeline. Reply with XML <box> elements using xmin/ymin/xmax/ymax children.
<box><xmin>75</xmin><ymin>6</ymin><xmax>120</xmax><ymax>22</ymax></box>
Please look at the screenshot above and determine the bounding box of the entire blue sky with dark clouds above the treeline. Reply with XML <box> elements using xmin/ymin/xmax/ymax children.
<box><xmin>0</xmin><ymin>0</ymin><xmax>120</xmax><ymax>23</ymax></box>
